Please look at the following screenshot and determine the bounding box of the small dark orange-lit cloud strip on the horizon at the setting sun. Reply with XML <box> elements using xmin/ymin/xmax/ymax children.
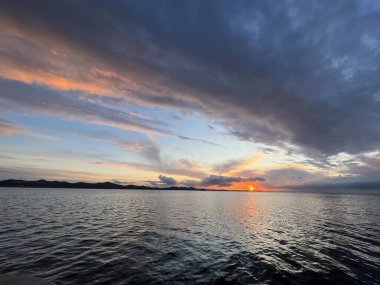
<box><xmin>181</xmin><ymin>175</ymin><xmax>265</xmax><ymax>187</ymax></box>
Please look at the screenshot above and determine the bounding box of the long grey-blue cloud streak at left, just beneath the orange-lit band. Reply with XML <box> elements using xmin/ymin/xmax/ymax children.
<box><xmin>0</xmin><ymin>80</ymin><xmax>170</xmax><ymax>135</ymax></box>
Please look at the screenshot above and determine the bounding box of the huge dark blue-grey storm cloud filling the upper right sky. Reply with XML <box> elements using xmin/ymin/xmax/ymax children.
<box><xmin>0</xmin><ymin>0</ymin><xmax>380</xmax><ymax>155</ymax></box>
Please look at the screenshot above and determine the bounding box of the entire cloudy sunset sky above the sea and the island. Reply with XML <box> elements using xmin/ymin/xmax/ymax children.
<box><xmin>0</xmin><ymin>0</ymin><xmax>380</xmax><ymax>190</ymax></box>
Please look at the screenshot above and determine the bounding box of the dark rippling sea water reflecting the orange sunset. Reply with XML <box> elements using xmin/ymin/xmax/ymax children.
<box><xmin>0</xmin><ymin>188</ymin><xmax>380</xmax><ymax>284</ymax></box>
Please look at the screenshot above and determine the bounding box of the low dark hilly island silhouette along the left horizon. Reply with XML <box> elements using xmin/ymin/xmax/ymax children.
<box><xmin>0</xmin><ymin>179</ymin><xmax>208</xmax><ymax>191</ymax></box>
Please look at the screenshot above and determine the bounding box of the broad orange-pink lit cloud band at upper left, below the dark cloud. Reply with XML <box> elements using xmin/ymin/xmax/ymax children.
<box><xmin>0</xmin><ymin>12</ymin><xmax>202</xmax><ymax>112</ymax></box>
